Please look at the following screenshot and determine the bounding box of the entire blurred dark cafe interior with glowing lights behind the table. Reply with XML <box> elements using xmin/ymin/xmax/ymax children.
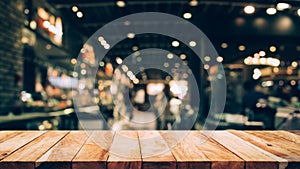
<box><xmin>0</xmin><ymin>0</ymin><xmax>300</xmax><ymax>130</ymax></box>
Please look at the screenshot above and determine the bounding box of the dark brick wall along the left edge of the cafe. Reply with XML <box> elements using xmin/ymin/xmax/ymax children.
<box><xmin>0</xmin><ymin>0</ymin><xmax>25</xmax><ymax>114</ymax></box>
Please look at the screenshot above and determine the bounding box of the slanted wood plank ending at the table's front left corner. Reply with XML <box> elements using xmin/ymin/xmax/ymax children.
<box><xmin>0</xmin><ymin>131</ymin><xmax>68</xmax><ymax>169</ymax></box>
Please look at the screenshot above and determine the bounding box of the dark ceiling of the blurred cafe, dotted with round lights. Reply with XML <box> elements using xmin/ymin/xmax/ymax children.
<box><xmin>48</xmin><ymin>0</ymin><xmax>300</xmax><ymax>63</ymax></box>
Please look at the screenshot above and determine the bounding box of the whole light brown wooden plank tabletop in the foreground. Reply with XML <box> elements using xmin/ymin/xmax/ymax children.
<box><xmin>0</xmin><ymin>130</ymin><xmax>300</xmax><ymax>169</ymax></box>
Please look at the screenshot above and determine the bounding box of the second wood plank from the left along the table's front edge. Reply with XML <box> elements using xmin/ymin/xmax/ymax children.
<box><xmin>36</xmin><ymin>131</ymin><xmax>88</xmax><ymax>169</ymax></box>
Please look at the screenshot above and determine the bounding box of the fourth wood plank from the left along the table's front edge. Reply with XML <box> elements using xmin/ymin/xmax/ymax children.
<box><xmin>107</xmin><ymin>131</ymin><xmax>142</xmax><ymax>169</ymax></box>
